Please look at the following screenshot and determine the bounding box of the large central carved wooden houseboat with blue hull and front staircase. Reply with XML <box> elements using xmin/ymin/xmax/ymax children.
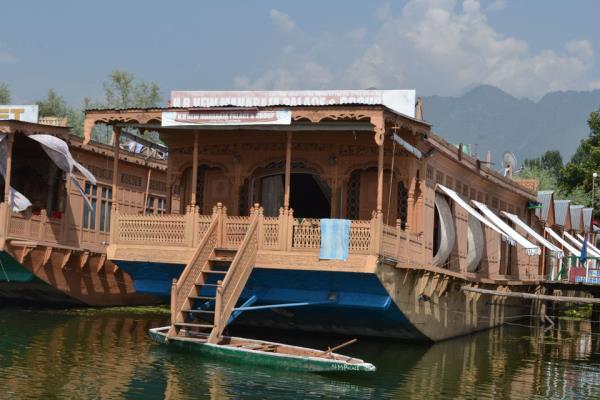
<box><xmin>84</xmin><ymin>90</ymin><xmax>580</xmax><ymax>342</ymax></box>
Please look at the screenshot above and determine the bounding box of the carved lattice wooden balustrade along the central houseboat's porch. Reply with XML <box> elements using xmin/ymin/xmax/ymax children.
<box><xmin>111</xmin><ymin>205</ymin><xmax>422</xmax><ymax>261</ymax></box>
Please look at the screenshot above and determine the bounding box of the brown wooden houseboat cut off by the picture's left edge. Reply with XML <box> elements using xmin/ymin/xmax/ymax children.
<box><xmin>0</xmin><ymin>120</ymin><xmax>166</xmax><ymax>306</ymax></box>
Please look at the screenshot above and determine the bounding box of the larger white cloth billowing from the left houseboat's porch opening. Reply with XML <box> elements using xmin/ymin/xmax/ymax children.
<box><xmin>28</xmin><ymin>134</ymin><xmax>97</xmax><ymax>210</ymax></box>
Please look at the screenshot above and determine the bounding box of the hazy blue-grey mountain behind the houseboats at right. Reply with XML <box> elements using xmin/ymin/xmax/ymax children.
<box><xmin>423</xmin><ymin>85</ymin><xmax>600</xmax><ymax>163</ymax></box>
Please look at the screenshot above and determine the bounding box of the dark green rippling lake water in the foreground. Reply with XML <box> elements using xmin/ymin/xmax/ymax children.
<box><xmin>0</xmin><ymin>308</ymin><xmax>600</xmax><ymax>399</ymax></box>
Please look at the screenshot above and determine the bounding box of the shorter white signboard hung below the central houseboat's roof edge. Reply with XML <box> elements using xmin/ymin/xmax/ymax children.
<box><xmin>162</xmin><ymin>110</ymin><xmax>292</xmax><ymax>126</ymax></box>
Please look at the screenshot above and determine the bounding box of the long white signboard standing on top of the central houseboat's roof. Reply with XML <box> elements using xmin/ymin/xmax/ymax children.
<box><xmin>171</xmin><ymin>90</ymin><xmax>416</xmax><ymax>118</ymax></box>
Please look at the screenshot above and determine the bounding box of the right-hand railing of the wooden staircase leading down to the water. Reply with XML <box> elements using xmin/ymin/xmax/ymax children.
<box><xmin>208</xmin><ymin>207</ymin><xmax>263</xmax><ymax>343</ymax></box>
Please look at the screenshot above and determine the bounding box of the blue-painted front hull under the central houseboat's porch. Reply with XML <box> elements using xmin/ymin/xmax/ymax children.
<box><xmin>115</xmin><ymin>261</ymin><xmax>428</xmax><ymax>340</ymax></box>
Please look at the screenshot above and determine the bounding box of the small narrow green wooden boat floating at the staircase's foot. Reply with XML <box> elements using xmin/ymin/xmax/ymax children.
<box><xmin>149</xmin><ymin>326</ymin><xmax>375</xmax><ymax>372</ymax></box>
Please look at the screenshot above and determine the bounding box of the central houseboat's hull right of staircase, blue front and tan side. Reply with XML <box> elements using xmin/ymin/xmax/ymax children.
<box><xmin>117</xmin><ymin>265</ymin><xmax>535</xmax><ymax>341</ymax></box>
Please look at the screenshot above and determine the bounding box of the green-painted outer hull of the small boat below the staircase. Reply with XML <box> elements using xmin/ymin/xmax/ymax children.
<box><xmin>149</xmin><ymin>328</ymin><xmax>375</xmax><ymax>372</ymax></box>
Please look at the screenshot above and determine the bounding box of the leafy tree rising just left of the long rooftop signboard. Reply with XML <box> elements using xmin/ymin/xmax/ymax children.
<box><xmin>103</xmin><ymin>70</ymin><xmax>162</xmax><ymax>108</ymax></box>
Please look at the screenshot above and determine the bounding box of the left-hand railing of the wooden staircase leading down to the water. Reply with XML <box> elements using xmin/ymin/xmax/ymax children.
<box><xmin>169</xmin><ymin>212</ymin><xmax>222</xmax><ymax>337</ymax></box>
